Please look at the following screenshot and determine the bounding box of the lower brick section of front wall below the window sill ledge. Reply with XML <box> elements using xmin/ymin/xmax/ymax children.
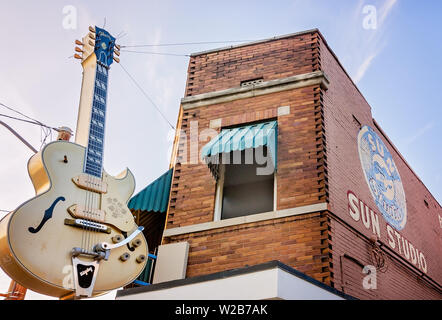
<box><xmin>167</xmin><ymin>212</ymin><xmax>330</xmax><ymax>283</ymax></box>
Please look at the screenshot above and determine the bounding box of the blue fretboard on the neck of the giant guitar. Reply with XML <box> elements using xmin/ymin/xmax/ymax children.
<box><xmin>84</xmin><ymin>62</ymin><xmax>109</xmax><ymax>178</ymax></box>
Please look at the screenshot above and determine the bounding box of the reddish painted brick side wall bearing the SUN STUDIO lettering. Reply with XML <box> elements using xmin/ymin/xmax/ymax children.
<box><xmin>320</xmin><ymin>34</ymin><xmax>442</xmax><ymax>299</ymax></box>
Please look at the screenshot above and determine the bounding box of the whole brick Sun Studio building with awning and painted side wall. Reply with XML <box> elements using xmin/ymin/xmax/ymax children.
<box><xmin>119</xmin><ymin>29</ymin><xmax>442</xmax><ymax>299</ymax></box>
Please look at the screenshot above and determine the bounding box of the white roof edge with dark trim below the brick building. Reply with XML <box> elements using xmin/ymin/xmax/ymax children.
<box><xmin>116</xmin><ymin>261</ymin><xmax>354</xmax><ymax>300</ymax></box>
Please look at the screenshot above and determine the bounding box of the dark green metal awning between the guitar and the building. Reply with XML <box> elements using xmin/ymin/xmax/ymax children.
<box><xmin>127</xmin><ymin>169</ymin><xmax>173</xmax><ymax>213</ymax></box>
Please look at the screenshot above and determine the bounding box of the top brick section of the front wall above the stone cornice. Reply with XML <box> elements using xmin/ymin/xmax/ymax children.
<box><xmin>186</xmin><ymin>32</ymin><xmax>319</xmax><ymax>96</ymax></box>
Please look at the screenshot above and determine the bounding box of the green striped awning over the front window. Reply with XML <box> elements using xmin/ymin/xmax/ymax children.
<box><xmin>201</xmin><ymin>121</ymin><xmax>278</xmax><ymax>169</ymax></box>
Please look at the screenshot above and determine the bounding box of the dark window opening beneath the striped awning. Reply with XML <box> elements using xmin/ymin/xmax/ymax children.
<box><xmin>215</xmin><ymin>147</ymin><xmax>275</xmax><ymax>220</ymax></box>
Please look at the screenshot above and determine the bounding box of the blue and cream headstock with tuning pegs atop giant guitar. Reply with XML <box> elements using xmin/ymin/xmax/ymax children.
<box><xmin>74</xmin><ymin>27</ymin><xmax>120</xmax><ymax>68</ymax></box>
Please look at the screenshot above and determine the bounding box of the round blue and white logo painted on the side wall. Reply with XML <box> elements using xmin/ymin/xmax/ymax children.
<box><xmin>358</xmin><ymin>126</ymin><xmax>407</xmax><ymax>230</ymax></box>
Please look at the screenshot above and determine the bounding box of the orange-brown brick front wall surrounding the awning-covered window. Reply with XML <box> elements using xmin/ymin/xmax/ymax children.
<box><xmin>163</xmin><ymin>33</ymin><xmax>330</xmax><ymax>283</ymax></box>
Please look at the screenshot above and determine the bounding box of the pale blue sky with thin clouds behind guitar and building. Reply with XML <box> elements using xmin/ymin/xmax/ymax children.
<box><xmin>0</xmin><ymin>0</ymin><xmax>442</xmax><ymax>299</ymax></box>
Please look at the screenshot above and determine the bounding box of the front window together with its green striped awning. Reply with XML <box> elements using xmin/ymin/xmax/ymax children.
<box><xmin>201</xmin><ymin>120</ymin><xmax>278</xmax><ymax>221</ymax></box>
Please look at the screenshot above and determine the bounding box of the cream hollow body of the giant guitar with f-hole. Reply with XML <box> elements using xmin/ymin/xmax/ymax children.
<box><xmin>0</xmin><ymin>141</ymin><xmax>148</xmax><ymax>297</ymax></box>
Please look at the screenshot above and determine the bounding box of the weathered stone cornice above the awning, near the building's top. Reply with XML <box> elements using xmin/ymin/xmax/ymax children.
<box><xmin>181</xmin><ymin>71</ymin><xmax>329</xmax><ymax>110</ymax></box>
